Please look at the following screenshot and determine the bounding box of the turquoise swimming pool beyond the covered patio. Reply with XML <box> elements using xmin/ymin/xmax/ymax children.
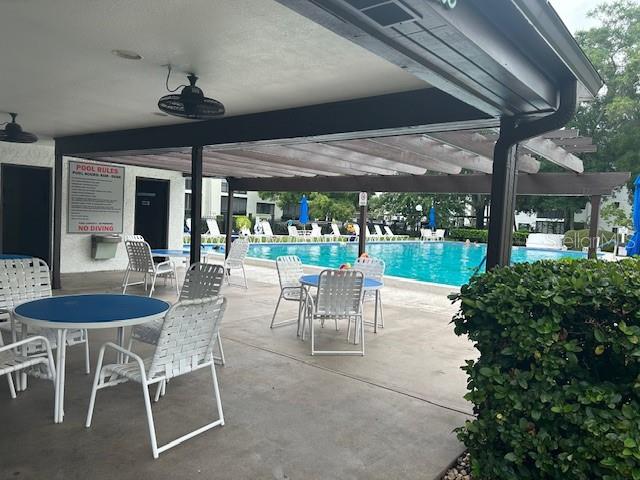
<box><xmin>249</xmin><ymin>242</ymin><xmax>586</xmax><ymax>286</ymax></box>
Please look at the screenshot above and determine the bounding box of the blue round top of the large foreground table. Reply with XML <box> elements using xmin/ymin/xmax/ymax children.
<box><xmin>14</xmin><ymin>294</ymin><xmax>169</xmax><ymax>323</ymax></box>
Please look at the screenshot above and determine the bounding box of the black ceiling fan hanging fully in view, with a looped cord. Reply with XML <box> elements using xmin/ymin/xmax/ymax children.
<box><xmin>158</xmin><ymin>65</ymin><xmax>225</xmax><ymax>120</ymax></box>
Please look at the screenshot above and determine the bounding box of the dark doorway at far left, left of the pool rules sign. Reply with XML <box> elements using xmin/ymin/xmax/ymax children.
<box><xmin>0</xmin><ymin>164</ymin><xmax>52</xmax><ymax>264</ymax></box>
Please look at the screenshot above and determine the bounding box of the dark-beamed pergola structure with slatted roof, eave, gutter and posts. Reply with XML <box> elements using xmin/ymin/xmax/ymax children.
<box><xmin>48</xmin><ymin>0</ymin><xmax>629</xmax><ymax>285</ymax></box>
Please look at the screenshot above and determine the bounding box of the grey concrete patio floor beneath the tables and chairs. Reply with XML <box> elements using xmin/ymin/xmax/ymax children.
<box><xmin>0</xmin><ymin>262</ymin><xmax>475</xmax><ymax>480</ymax></box>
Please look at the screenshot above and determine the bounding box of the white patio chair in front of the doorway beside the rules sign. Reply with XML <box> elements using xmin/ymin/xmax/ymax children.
<box><xmin>122</xmin><ymin>240</ymin><xmax>180</xmax><ymax>296</ymax></box>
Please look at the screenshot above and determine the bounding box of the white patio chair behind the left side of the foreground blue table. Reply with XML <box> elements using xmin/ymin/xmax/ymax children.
<box><xmin>0</xmin><ymin>258</ymin><xmax>91</xmax><ymax>391</ymax></box>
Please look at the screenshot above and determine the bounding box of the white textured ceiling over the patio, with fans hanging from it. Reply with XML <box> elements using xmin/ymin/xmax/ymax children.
<box><xmin>0</xmin><ymin>0</ymin><xmax>427</xmax><ymax>137</ymax></box>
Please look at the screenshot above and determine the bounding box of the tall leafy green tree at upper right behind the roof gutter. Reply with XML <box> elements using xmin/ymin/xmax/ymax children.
<box><xmin>517</xmin><ymin>0</ymin><xmax>640</xmax><ymax>223</ymax></box>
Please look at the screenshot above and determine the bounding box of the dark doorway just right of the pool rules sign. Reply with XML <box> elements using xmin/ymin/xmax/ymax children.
<box><xmin>133</xmin><ymin>177</ymin><xmax>169</xmax><ymax>248</ymax></box>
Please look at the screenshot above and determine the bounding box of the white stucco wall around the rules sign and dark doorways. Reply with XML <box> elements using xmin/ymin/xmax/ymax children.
<box><xmin>0</xmin><ymin>143</ymin><xmax>184</xmax><ymax>273</ymax></box>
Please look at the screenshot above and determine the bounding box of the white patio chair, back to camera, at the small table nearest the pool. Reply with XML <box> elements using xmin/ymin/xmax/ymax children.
<box><xmin>302</xmin><ymin>270</ymin><xmax>364</xmax><ymax>355</ymax></box>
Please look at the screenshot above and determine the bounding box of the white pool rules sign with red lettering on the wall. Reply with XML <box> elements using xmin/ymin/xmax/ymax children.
<box><xmin>67</xmin><ymin>161</ymin><xmax>124</xmax><ymax>233</ymax></box>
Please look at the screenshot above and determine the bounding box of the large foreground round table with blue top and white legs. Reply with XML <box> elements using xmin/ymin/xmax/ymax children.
<box><xmin>14</xmin><ymin>294</ymin><xmax>170</xmax><ymax>423</ymax></box>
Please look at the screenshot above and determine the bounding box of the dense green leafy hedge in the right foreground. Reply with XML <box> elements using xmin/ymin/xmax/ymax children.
<box><xmin>451</xmin><ymin>259</ymin><xmax>640</xmax><ymax>480</ymax></box>
